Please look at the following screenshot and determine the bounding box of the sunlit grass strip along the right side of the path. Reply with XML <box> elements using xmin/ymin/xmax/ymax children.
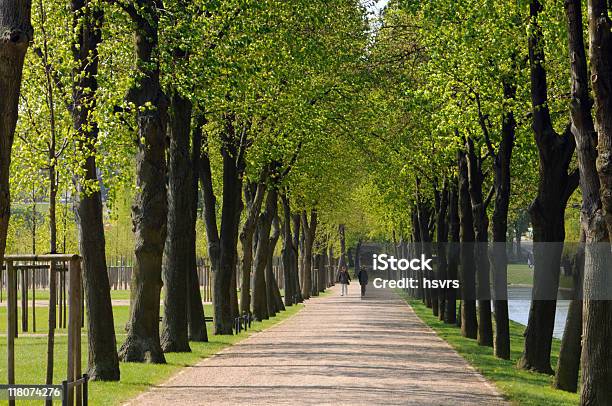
<box><xmin>397</xmin><ymin>290</ymin><xmax>579</xmax><ymax>406</ymax></box>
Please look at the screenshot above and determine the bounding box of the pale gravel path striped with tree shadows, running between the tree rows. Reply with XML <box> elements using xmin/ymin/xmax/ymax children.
<box><xmin>131</xmin><ymin>283</ymin><xmax>506</xmax><ymax>406</ymax></box>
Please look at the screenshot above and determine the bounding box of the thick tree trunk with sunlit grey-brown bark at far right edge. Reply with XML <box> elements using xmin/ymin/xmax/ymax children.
<box><xmin>580</xmin><ymin>0</ymin><xmax>612</xmax><ymax>405</ymax></box>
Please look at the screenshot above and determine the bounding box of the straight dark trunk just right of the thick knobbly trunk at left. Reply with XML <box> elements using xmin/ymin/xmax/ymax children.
<box><xmin>161</xmin><ymin>89</ymin><xmax>194</xmax><ymax>352</ymax></box>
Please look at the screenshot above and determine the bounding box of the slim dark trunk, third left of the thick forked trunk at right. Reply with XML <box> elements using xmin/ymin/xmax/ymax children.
<box><xmin>458</xmin><ymin>152</ymin><xmax>478</xmax><ymax>338</ymax></box>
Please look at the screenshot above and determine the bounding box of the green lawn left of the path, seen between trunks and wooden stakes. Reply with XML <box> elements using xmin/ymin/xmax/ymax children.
<box><xmin>0</xmin><ymin>305</ymin><xmax>303</xmax><ymax>405</ymax></box>
